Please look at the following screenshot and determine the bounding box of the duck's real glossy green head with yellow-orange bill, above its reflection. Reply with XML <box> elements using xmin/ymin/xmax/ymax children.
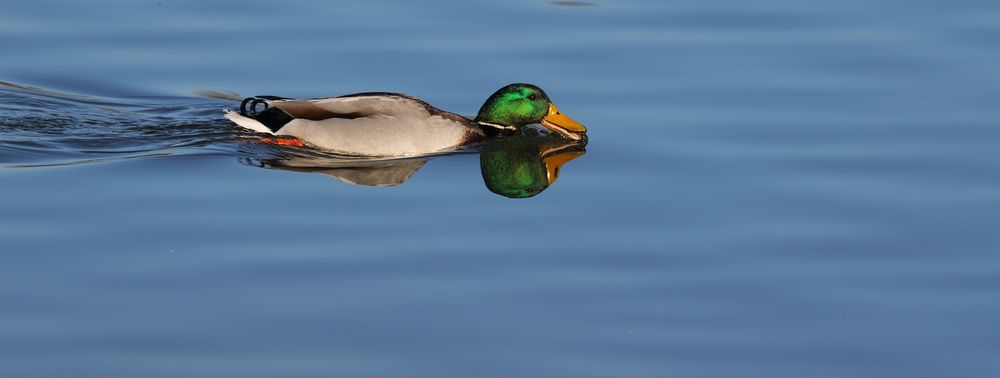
<box><xmin>475</xmin><ymin>83</ymin><xmax>587</xmax><ymax>140</ymax></box>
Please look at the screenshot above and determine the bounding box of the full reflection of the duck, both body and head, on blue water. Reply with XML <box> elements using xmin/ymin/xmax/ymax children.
<box><xmin>241</xmin><ymin>135</ymin><xmax>587</xmax><ymax>198</ymax></box>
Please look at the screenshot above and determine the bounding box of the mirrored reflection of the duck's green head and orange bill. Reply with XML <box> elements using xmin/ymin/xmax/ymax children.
<box><xmin>479</xmin><ymin>137</ymin><xmax>587</xmax><ymax>198</ymax></box>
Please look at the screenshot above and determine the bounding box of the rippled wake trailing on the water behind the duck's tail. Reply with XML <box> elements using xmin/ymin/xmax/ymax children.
<box><xmin>0</xmin><ymin>82</ymin><xmax>350</xmax><ymax>168</ymax></box>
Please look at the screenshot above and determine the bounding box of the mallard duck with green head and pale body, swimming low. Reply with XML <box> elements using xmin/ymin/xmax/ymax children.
<box><xmin>226</xmin><ymin>83</ymin><xmax>587</xmax><ymax>156</ymax></box>
